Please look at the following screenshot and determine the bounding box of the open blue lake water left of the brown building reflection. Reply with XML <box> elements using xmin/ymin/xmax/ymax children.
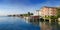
<box><xmin>0</xmin><ymin>17</ymin><xmax>40</xmax><ymax>30</ymax></box>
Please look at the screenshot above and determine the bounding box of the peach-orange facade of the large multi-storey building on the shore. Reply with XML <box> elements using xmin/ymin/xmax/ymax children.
<box><xmin>41</xmin><ymin>6</ymin><xmax>57</xmax><ymax>16</ymax></box>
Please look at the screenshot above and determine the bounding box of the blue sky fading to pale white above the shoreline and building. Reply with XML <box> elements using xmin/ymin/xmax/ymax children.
<box><xmin>0</xmin><ymin>0</ymin><xmax>60</xmax><ymax>15</ymax></box>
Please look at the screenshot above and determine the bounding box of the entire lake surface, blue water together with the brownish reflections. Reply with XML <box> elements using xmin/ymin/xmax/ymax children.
<box><xmin>0</xmin><ymin>17</ymin><xmax>60</xmax><ymax>30</ymax></box>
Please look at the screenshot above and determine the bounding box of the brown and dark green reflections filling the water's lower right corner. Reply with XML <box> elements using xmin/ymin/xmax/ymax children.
<box><xmin>40</xmin><ymin>22</ymin><xmax>60</xmax><ymax>30</ymax></box>
